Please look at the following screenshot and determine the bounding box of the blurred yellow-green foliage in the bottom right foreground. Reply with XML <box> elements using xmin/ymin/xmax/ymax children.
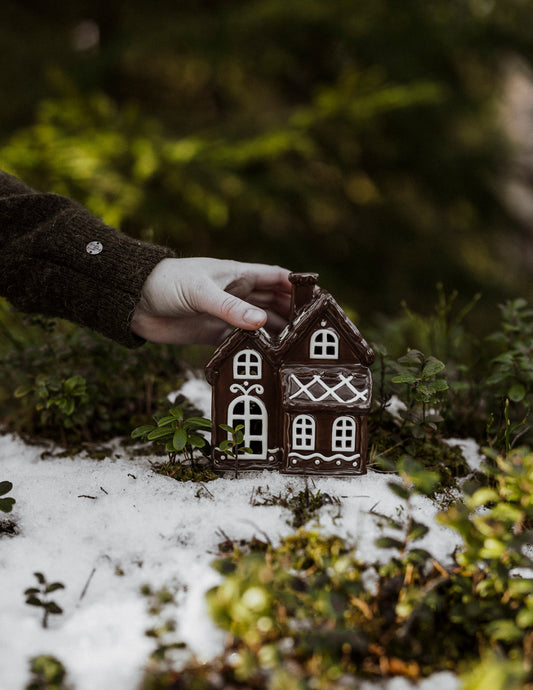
<box><xmin>138</xmin><ymin>448</ymin><xmax>533</xmax><ymax>690</ymax></box>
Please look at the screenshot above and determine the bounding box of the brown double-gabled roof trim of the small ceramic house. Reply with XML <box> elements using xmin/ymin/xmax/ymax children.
<box><xmin>205</xmin><ymin>289</ymin><xmax>375</xmax><ymax>383</ymax></box>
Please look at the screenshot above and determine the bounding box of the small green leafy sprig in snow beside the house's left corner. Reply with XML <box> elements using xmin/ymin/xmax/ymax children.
<box><xmin>131</xmin><ymin>407</ymin><xmax>211</xmax><ymax>465</ymax></box>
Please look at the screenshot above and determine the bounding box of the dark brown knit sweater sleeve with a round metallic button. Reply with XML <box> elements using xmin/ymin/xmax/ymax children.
<box><xmin>0</xmin><ymin>171</ymin><xmax>172</xmax><ymax>347</ymax></box>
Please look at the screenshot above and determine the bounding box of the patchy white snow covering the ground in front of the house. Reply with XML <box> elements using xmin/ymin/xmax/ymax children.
<box><xmin>0</xmin><ymin>380</ymin><xmax>478</xmax><ymax>690</ymax></box>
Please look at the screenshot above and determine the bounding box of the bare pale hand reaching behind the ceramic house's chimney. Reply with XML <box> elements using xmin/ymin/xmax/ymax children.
<box><xmin>131</xmin><ymin>258</ymin><xmax>292</xmax><ymax>345</ymax></box>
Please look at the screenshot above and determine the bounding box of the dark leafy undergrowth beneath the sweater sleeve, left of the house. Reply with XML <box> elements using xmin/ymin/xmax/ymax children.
<box><xmin>0</xmin><ymin>299</ymin><xmax>182</xmax><ymax>450</ymax></box>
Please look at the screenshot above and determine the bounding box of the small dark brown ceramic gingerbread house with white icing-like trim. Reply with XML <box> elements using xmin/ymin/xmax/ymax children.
<box><xmin>205</xmin><ymin>273</ymin><xmax>374</xmax><ymax>476</ymax></box>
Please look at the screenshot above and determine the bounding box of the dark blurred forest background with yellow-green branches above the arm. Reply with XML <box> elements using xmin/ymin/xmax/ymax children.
<box><xmin>0</xmin><ymin>0</ymin><xmax>533</xmax><ymax>334</ymax></box>
